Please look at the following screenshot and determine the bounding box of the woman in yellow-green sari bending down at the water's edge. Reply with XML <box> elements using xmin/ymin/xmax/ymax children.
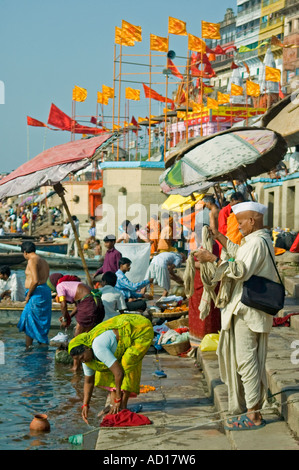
<box><xmin>69</xmin><ymin>314</ymin><xmax>154</xmax><ymax>423</ymax></box>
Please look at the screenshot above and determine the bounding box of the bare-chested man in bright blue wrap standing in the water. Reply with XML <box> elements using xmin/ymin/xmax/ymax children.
<box><xmin>18</xmin><ymin>241</ymin><xmax>52</xmax><ymax>348</ymax></box>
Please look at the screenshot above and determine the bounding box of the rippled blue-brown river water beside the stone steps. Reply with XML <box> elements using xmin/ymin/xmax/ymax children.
<box><xmin>0</xmin><ymin>271</ymin><xmax>107</xmax><ymax>450</ymax></box>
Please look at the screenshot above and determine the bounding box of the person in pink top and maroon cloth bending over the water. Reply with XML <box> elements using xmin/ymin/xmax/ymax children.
<box><xmin>48</xmin><ymin>273</ymin><xmax>105</xmax><ymax>371</ymax></box>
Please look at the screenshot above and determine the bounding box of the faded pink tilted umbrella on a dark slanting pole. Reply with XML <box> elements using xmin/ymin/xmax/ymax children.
<box><xmin>0</xmin><ymin>134</ymin><xmax>116</xmax><ymax>287</ymax></box>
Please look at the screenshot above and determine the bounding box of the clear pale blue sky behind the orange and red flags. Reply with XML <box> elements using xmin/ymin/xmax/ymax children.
<box><xmin>0</xmin><ymin>0</ymin><xmax>237</xmax><ymax>174</ymax></box>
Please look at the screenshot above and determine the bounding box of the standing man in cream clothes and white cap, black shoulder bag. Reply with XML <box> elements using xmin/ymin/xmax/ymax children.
<box><xmin>196</xmin><ymin>202</ymin><xmax>277</xmax><ymax>429</ymax></box>
